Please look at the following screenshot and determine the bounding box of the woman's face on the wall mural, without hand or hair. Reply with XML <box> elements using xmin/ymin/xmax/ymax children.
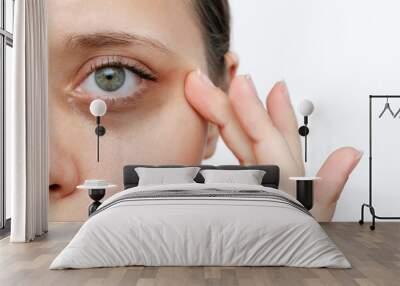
<box><xmin>48</xmin><ymin>0</ymin><xmax>216</xmax><ymax>221</ymax></box>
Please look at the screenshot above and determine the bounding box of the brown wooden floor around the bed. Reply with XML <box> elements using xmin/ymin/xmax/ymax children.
<box><xmin>0</xmin><ymin>222</ymin><xmax>400</xmax><ymax>286</ymax></box>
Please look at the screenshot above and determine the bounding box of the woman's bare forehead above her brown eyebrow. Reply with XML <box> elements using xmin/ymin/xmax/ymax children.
<box><xmin>48</xmin><ymin>0</ymin><xmax>203</xmax><ymax>56</ymax></box>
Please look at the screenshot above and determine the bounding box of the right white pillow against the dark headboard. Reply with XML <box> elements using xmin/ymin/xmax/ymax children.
<box><xmin>200</xmin><ymin>170</ymin><xmax>265</xmax><ymax>185</ymax></box>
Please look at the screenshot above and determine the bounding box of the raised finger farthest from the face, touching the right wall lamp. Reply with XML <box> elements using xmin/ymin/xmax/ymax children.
<box><xmin>266</xmin><ymin>81</ymin><xmax>304</xmax><ymax>170</ymax></box>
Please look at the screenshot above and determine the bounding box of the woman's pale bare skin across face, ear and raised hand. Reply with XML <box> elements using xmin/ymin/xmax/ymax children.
<box><xmin>47</xmin><ymin>0</ymin><xmax>361</xmax><ymax>221</ymax></box>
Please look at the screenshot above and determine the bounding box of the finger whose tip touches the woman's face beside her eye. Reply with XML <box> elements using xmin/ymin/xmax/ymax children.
<box><xmin>185</xmin><ymin>71</ymin><xmax>255</xmax><ymax>165</ymax></box>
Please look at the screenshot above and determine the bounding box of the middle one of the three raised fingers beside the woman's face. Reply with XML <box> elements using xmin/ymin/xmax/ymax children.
<box><xmin>229</xmin><ymin>76</ymin><xmax>302</xmax><ymax>194</ymax></box>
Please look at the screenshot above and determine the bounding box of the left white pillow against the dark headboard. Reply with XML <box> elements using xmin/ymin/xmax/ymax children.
<box><xmin>135</xmin><ymin>167</ymin><xmax>200</xmax><ymax>186</ymax></box>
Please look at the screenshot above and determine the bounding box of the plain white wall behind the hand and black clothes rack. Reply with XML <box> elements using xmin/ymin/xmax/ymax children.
<box><xmin>205</xmin><ymin>0</ymin><xmax>400</xmax><ymax>221</ymax></box>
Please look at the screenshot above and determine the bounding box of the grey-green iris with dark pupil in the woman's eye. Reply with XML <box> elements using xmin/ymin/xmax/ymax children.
<box><xmin>94</xmin><ymin>67</ymin><xmax>125</xmax><ymax>92</ymax></box>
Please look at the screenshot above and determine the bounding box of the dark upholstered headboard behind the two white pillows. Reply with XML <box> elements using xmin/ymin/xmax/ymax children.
<box><xmin>124</xmin><ymin>165</ymin><xmax>279</xmax><ymax>190</ymax></box>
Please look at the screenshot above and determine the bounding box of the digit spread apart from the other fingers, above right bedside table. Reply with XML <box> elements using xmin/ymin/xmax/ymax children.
<box><xmin>312</xmin><ymin>147</ymin><xmax>363</xmax><ymax>221</ymax></box>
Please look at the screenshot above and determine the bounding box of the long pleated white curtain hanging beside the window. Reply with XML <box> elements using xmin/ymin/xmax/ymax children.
<box><xmin>6</xmin><ymin>0</ymin><xmax>49</xmax><ymax>242</ymax></box>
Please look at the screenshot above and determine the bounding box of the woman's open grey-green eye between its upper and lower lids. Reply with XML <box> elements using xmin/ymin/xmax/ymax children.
<box><xmin>80</xmin><ymin>66</ymin><xmax>143</xmax><ymax>99</ymax></box>
